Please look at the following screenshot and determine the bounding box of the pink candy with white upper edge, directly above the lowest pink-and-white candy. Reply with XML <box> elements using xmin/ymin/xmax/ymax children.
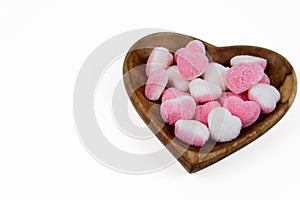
<box><xmin>160</xmin><ymin>96</ymin><xmax>196</xmax><ymax>125</ymax></box>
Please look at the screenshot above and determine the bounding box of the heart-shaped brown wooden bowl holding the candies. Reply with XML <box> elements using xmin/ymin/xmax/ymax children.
<box><xmin>123</xmin><ymin>32</ymin><xmax>297</xmax><ymax>173</ymax></box>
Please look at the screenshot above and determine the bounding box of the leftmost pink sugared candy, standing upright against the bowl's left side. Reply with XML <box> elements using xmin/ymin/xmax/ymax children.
<box><xmin>145</xmin><ymin>69</ymin><xmax>168</xmax><ymax>101</ymax></box>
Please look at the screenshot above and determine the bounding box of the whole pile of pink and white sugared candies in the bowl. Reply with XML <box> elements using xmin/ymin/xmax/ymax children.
<box><xmin>145</xmin><ymin>40</ymin><xmax>280</xmax><ymax>146</ymax></box>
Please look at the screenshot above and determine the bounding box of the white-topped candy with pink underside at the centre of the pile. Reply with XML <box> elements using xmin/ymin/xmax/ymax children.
<box><xmin>189</xmin><ymin>78</ymin><xmax>222</xmax><ymax>103</ymax></box>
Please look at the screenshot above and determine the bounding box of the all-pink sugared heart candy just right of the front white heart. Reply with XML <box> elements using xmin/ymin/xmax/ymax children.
<box><xmin>223</xmin><ymin>96</ymin><xmax>260</xmax><ymax>128</ymax></box>
